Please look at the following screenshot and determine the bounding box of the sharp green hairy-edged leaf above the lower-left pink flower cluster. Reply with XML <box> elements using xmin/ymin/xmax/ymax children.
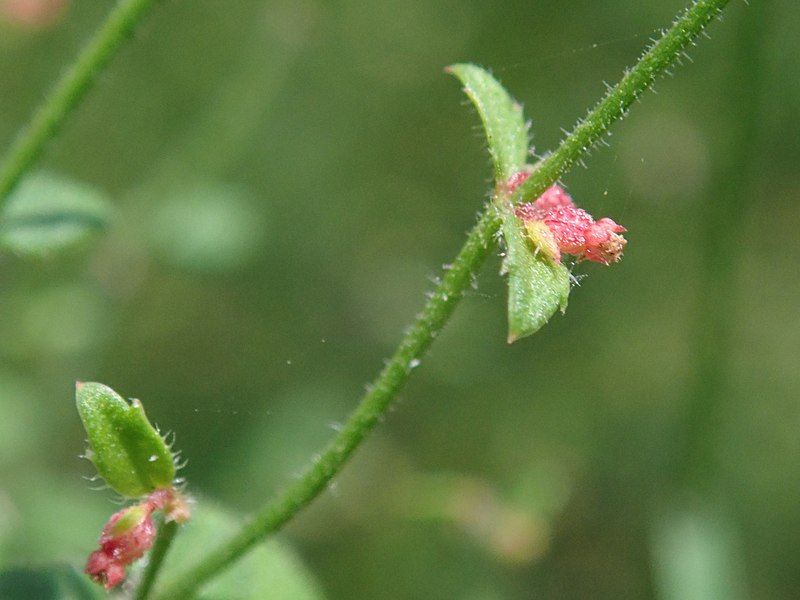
<box><xmin>75</xmin><ymin>382</ymin><xmax>175</xmax><ymax>498</ymax></box>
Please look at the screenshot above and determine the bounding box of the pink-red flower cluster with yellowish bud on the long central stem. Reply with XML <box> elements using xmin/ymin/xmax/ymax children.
<box><xmin>507</xmin><ymin>172</ymin><xmax>628</xmax><ymax>265</ymax></box>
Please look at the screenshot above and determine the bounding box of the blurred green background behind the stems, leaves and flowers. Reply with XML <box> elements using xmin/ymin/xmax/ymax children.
<box><xmin>0</xmin><ymin>0</ymin><xmax>800</xmax><ymax>600</ymax></box>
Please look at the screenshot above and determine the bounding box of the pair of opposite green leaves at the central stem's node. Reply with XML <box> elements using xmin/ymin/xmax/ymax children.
<box><xmin>449</xmin><ymin>64</ymin><xmax>570</xmax><ymax>343</ymax></box>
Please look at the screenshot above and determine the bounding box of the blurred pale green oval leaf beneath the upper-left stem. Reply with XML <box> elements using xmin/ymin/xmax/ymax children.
<box><xmin>0</xmin><ymin>173</ymin><xmax>111</xmax><ymax>257</ymax></box>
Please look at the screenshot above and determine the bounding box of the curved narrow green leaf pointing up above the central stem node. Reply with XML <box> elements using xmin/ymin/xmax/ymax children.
<box><xmin>447</xmin><ymin>64</ymin><xmax>528</xmax><ymax>184</ymax></box>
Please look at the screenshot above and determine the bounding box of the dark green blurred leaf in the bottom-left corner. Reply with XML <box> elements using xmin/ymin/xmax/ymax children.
<box><xmin>0</xmin><ymin>565</ymin><xmax>105</xmax><ymax>600</ymax></box>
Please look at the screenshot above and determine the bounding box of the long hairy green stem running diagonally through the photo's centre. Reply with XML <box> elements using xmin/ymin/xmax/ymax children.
<box><xmin>152</xmin><ymin>0</ymin><xmax>730</xmax><ymax>600</ymax></box>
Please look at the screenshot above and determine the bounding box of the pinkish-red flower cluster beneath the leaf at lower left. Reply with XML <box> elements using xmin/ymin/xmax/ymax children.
<box><xmin>86</xmin><ymin>488</ymin><xmax>189</xmax><ymax>590</ymax></box>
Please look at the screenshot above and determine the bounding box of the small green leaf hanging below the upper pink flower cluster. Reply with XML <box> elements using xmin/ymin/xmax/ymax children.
<box><xmin>502</xmin><ymin>207</ymin><xmax>570</xmax><ymax>344</ymax></box>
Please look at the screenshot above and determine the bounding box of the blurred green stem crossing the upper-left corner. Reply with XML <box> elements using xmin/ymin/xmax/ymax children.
<box><xmin>0</xmin><ymin>0</ymin><xmax>160</xmax><ymax>206</ymax></box>
